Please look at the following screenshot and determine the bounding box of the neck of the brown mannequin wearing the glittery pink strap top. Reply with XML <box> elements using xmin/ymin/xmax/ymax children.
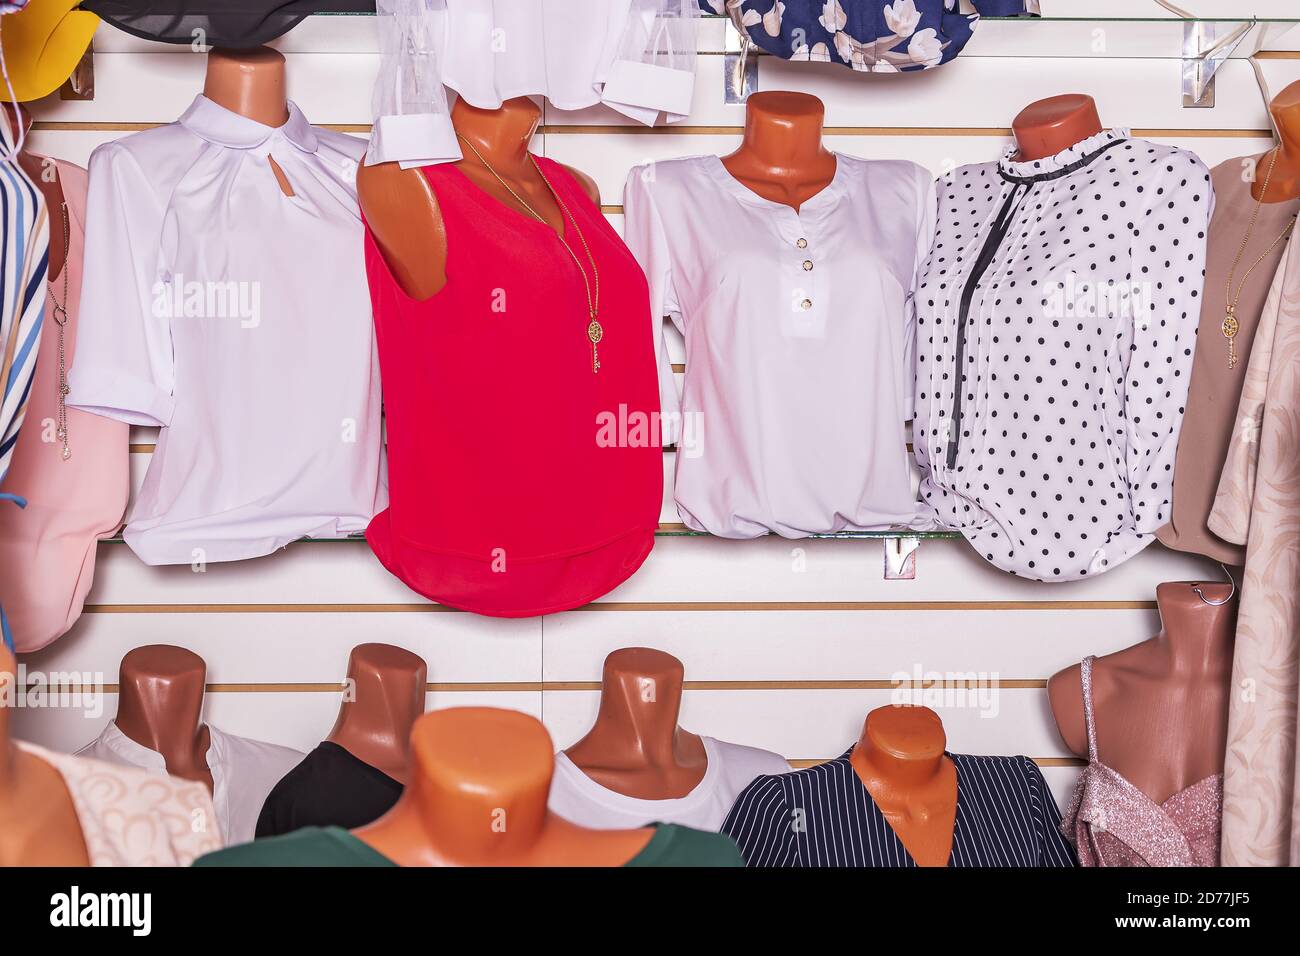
<box><xmin>1156</xmin><ymin>581</ymin><xmax>1236</xmax><ymax>675</ymax></box>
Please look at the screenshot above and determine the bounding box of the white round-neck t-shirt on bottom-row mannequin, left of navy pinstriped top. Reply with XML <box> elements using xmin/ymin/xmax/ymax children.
<box><xmin>547</xmin><ymin>736</ymin><xmax>790</xmax><ymax>832</ymax></box>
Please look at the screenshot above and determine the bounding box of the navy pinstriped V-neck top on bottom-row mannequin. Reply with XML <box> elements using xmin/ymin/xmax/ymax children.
<box><xmin>723</xmin><ymin>748</ymin><xmax>1076</xmax><ymax>866</ymax></box>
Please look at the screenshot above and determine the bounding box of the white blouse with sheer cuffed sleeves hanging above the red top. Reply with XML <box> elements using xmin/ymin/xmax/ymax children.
<box><xmin>367</xmin><ymin>0</ymin><xmax>699</xmax><ymax>166</ymax></box>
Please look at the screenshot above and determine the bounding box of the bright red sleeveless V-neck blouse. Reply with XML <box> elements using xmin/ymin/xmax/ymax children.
<box><xmin>365</xmin><ymin>157</ymin><xmax>663</xmax><ymax>617</ymax></box>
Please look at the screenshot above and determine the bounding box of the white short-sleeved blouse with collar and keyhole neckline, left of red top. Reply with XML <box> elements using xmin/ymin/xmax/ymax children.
<box><xmin>68</xmin><ymin>96</ymin><xmax>387</xmax><ymax>564</ymax></box>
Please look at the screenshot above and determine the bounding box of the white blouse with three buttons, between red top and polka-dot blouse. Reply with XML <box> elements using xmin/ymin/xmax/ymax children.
<box><xmin>624</xmin><ymin>153</ymin><xmax>933</xmax><ymax>538</ymax></box>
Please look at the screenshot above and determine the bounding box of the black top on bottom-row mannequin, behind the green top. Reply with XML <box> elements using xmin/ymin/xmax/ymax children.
<box><xmin>256</xmin><ymin>740</ymin><xmax>402</xmax><ymax>838</ymax></box>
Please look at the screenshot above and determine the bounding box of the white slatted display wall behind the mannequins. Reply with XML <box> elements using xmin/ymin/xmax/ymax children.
<box><xmin>14</xmin><ymin>0</ymin><xmax>1300</xmax><ymax>800</ymax></box>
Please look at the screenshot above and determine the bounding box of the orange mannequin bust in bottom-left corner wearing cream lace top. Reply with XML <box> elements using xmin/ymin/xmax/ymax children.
<box><xmin>0</xmin><ymin>644</ymin><xmax>90</xmax><ymax>868</ymax></box>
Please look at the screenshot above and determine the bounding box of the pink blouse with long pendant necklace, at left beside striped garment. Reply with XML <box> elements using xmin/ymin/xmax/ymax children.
<box><xmin>0</xmin><ymin>161</ymin><xmax>130</xmax><ymax>652</ymax></box>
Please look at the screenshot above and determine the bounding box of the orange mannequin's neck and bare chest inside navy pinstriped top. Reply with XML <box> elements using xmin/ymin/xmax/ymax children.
<box><xmin>849</xmin><ymin>705</ymin><xmax>957</xmax><ymax>866</ymax></box>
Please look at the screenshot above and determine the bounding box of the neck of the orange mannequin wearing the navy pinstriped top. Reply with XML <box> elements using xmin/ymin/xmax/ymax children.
<box><xmin>849</xmin><ymin>706</ymin><xmax>948</xmax><ymax>803</ymax></box>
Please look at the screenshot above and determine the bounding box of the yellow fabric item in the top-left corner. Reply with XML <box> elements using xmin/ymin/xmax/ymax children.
<box><xmin>0</xmin><ymin>0</ymin><xmax>99</xmax><ymax>103</ymax></box>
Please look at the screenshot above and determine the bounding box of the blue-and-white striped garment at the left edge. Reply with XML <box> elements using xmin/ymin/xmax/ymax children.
<box><xmin>0</xmin><ymin>117</ymin><xmax>49</xmax><ymax>481</ymax></box>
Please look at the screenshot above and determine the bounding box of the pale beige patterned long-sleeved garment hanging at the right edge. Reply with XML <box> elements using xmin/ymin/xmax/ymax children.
<box><xmin>1209</xmin><ymin>221</ymin><xmax>1300</xmax><ymax>866</ymax></box>
